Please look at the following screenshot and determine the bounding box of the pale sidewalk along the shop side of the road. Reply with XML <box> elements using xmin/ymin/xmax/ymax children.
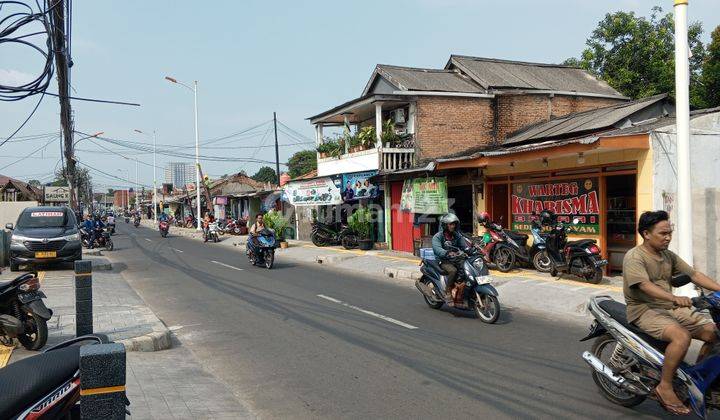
<box><xmin>160</xmin><ymin>224</ymin><xmax>624</xmax><ymax>323</ymax></box>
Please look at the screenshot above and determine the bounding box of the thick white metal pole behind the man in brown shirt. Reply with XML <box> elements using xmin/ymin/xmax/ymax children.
<box><xmin>674</xmin><ymin>0</ymin><xmax>696</xmax><ymax>296</ymax></box>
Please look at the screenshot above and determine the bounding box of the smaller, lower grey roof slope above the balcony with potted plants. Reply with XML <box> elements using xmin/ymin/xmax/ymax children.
<box><xmin>375</xmin><ymin>64</ymin><xmax>484</xmax><ymax>93</ymax></box>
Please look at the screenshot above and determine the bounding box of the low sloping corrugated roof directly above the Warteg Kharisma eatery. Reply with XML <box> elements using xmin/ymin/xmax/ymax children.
<box><xmin>503</xmin><ymin>94</ymin><xmax>667</xmax><ymax>145</ymax></box>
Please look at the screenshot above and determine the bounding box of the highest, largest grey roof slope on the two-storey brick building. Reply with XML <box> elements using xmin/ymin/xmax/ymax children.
<box><xmin>445</xmin><ymin>55</ymin><xmax>623</xmax><ymax>98</ymax></box>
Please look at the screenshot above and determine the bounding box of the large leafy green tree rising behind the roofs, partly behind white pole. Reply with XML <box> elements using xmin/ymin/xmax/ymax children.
<box><xmin>565</xmin><ymin>7</ymin><xmax>705</xmax><ymax>107</ymax></box>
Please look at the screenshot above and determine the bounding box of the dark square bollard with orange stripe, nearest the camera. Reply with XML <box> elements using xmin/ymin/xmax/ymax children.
<box><xmin>80</xmin><ymin>343</ymin><xmax>126</xmax><ymax>420</ymax></box>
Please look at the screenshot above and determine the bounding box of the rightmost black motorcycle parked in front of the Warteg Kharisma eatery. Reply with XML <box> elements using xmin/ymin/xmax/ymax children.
<box><xmin>545</xmin><ymin>219</ymin><xmax>608</xmax><ymax>284</ymax></box>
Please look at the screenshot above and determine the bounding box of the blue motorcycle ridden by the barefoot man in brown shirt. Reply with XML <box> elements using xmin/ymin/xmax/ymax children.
<box><xmin>580</xmin><ymin>274</ymin><xmax>720</xmax><ymax>418</ymax></box>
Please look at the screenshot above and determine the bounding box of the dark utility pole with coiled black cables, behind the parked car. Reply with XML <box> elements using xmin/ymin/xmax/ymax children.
<box><xmin>47</xmin><ymin>0</ymin><xmax>78</xmax><ymax>210</ymax></box>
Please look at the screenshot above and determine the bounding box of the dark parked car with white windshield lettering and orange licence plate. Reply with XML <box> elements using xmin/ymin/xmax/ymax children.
<box><xmin>5</xmin><ymin>207</ymin><xmax>82</xmax><ymax>271</ymax></box>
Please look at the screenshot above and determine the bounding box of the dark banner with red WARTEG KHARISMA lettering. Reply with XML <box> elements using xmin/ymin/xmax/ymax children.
<box><xmin>511</xmin><ymin>177</ymin><xmax>600</xmax><ymax>235</ymax></box>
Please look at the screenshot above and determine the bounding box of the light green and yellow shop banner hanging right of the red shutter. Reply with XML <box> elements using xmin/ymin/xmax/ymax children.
<box><xmin>400</xmin><ymin>177</ymin><xmax>448</xmax><ymax>214</ymax></box>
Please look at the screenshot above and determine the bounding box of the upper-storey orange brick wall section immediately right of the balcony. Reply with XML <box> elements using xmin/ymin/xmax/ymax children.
<box><xmin>415</xmin><ymin>96</ymin><xmax>493</xmax><ymax>160</ymax></box>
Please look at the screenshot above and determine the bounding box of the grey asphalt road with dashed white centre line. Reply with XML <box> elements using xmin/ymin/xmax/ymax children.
<box><xmin>112</xmin><ymin>224</ymin><xmax>676</xmax><ymax>418</ymax></box>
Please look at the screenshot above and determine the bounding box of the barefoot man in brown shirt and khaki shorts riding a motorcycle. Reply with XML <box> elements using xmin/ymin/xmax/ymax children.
<box><xmin>623</xmin><ymin>211</ymin><xmax>720</xmax><ymax>414</ymax></box>
